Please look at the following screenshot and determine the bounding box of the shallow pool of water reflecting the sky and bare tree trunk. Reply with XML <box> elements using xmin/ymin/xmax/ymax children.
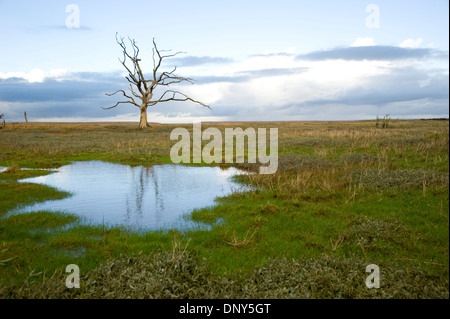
<box><xmin>14</xmin><ymin>161</ymin><xmax>247</xmax><ymax>230</ymax></box>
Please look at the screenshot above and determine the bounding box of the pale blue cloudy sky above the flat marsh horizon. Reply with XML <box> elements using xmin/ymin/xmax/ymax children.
<box><xmin>0</xmin><ymin>0</ymin><xmax>449</xmax><ymax>123</ymax></box>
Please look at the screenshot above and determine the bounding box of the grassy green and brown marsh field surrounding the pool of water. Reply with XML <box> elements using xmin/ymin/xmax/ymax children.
<box><xmin>0</xmin><ymin>120</ymin><xmax>449</xmax><ymax>299</ymax></box>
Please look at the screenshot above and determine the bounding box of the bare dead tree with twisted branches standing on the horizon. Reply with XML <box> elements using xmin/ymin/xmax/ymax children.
<box><xmin>104</xmin><ymin>33</ymin><xmax>210</xmax><ymax>128</ymax></box>
